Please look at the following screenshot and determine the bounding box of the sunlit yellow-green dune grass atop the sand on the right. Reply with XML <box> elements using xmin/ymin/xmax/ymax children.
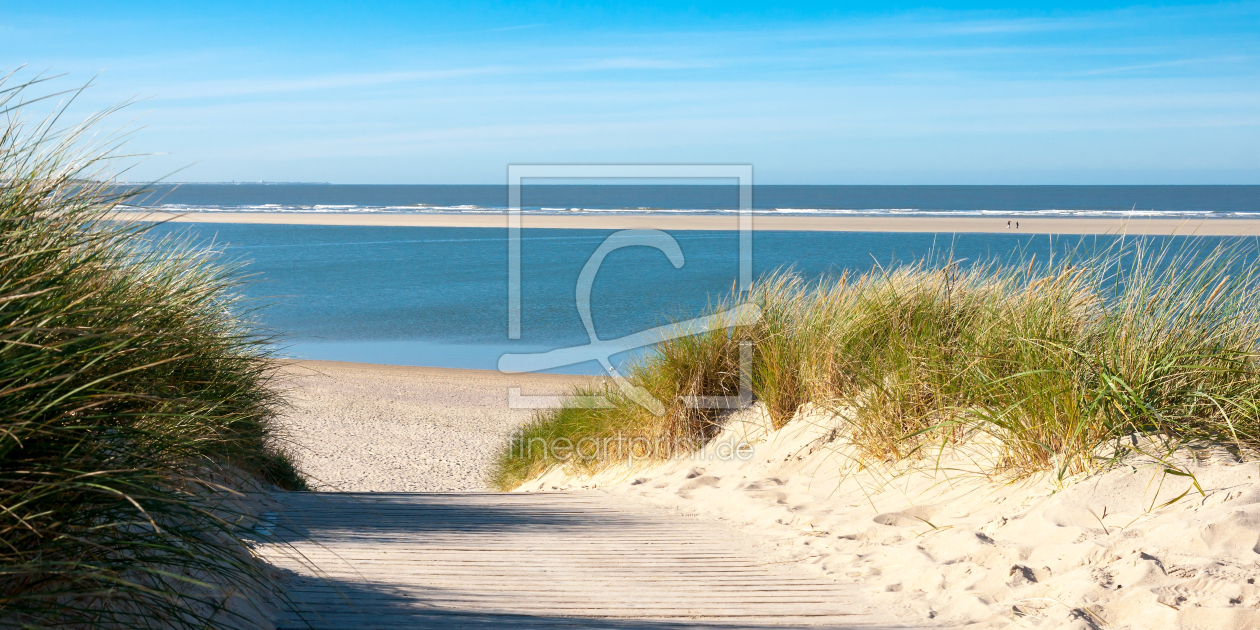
<box><xmin>491</xmin><ymin>239</ymin><xmax>1260</xmax><ymax>490</ymax></box>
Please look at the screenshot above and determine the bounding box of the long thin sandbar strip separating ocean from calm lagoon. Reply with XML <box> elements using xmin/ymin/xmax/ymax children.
<box><xmin>115</xmin><ymin>212</ymin><xmax>1260</xmax><ymax>236</ymax></box>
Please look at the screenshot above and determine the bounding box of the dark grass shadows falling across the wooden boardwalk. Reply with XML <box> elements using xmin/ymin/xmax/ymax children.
<box><xmin>260</xmin><ymin>493</ymin><xmax>927</xmax><ymax>630</ymax></box>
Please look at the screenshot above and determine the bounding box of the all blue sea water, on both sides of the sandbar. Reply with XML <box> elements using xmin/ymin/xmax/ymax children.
<box><xmin>131</xmin><ymin>183</ymin><xmax>1260</xmax><ymax>374</ymax></box>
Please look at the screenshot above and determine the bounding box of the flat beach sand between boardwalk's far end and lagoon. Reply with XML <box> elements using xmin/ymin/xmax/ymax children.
<box><xmin>272</xmin><ymin>360</ymin><xmax>590</xmax><ymax>491</ymax></box>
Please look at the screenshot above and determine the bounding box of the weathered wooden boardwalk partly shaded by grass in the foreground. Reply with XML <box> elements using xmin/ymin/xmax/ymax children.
<box><xmin>261</xmin><ymin>493</ymin><xmax>922</xmax><ymax>630</ymax></box>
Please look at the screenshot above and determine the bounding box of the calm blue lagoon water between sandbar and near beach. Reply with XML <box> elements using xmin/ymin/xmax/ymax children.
<box><xmin>144</xmin><ymin>224</ymin><xmax>1249</xmax><ymax>373</ymax></box>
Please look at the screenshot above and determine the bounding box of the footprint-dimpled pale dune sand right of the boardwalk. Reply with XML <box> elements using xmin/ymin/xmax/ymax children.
<box><xmin>522</xmin><ymin>408</ymin><xmax>1260</xmax><ymax>630</ymax></box>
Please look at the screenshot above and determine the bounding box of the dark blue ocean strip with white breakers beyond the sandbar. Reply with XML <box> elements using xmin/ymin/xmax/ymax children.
<box><xmin>132</xmin><ymin>183</ymin><xmax>1260</xmax><ymax>219</ymax></box>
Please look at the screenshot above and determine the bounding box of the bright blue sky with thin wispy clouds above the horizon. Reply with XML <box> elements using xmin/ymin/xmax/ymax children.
<box><xmin>0</xmin><ymin>1</ymin><xmax>1260</xmax><ymax>184</ymax></box>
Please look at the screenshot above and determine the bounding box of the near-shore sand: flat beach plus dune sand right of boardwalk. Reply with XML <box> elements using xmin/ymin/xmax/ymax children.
<box><xmin>275</xmin><ymin>360</ymin><xmax>1260</xmax><ymax>630</ymax></box>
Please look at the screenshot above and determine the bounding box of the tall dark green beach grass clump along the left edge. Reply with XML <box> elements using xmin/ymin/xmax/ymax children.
<box><xmin>0</xmin><ymin>77</ymin><xmax>304</xmax><ymax>627</ymax></box>
